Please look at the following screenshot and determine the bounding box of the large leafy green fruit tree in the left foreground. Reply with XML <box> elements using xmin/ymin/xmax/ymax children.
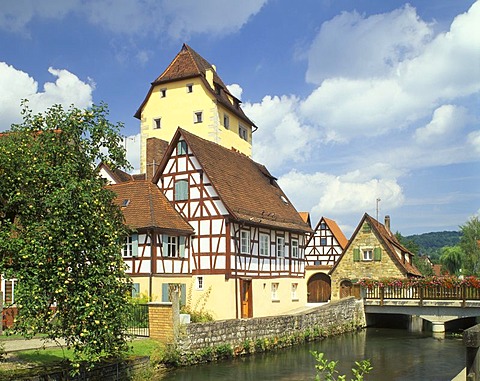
<box><xmin>0</xmin><ymin>103</ymin><xmax>131</xmax><ymax>366</ymax></box>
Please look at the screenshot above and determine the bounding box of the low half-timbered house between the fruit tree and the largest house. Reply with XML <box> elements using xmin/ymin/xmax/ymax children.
<box><xmin>108</xmin><ymin>180</ymin><xmax>193</xmax><ymax>301</ymax></box>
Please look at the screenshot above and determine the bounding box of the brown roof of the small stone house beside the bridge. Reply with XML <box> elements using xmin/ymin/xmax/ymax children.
<box><xmin>330</xmin><ymin>213</ymin><xmax>422</xmax><ymax>276</ymax></box>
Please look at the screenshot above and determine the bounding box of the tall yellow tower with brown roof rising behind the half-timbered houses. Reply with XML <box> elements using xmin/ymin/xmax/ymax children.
<box><xmin>135</xmin><ymin>44</ymin><xmax>257</xmax><ymax>172</ymax></box>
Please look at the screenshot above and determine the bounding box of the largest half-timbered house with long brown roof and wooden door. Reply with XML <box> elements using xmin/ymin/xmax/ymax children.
<box><xmin>153</xmin><ymin>129</ymin><xmax>311</xmax><ymax>319</ymax></box>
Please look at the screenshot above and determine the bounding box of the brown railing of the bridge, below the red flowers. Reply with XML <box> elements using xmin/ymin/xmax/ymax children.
<box><xmin>362</xmin><ymin>285</ymin><xmax>480</xmax><ymax>303</ymax></box>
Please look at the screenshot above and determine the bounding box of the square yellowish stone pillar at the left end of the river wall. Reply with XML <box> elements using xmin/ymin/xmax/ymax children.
<box><xmin>148</xmin><ymin>302</ymin><xmax>175</xmax><ymax>344</ymax></box>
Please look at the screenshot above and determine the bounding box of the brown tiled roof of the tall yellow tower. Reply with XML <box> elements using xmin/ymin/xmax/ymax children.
<box><xmin>135</xmin><ymin>44</ymin><xmax>256</xmax><ymax>127</ymax></box>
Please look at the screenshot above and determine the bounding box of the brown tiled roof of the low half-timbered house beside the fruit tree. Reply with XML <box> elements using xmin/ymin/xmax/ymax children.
<box><xmin>107</xmin><ymin>180</ymin><xmax>193</xmax><ymax>235</ymax></box>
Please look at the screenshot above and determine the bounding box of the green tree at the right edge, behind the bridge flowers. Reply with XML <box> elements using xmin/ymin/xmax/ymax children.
<box><xmin>459</xmin><ymin>216</ymin><xmax>480</xmax><ymax>276</ymax></box>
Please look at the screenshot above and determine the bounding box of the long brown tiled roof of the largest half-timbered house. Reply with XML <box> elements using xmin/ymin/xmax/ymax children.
<box><xmin>153</xmin><ymin>128</ymin><xmax>312</xmax><ymax>232</ymax></box>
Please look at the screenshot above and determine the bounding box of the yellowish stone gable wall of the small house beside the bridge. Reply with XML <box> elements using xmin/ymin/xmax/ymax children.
<box><xmin>331</xmin><ymin>221</ymin><xmax>405</xmax><ymax>300</ymax></box>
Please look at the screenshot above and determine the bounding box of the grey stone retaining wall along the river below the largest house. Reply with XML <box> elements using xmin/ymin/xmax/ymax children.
<box><xmin>176</xmin><ymin>298</ymin><xmax>365</xmax><ymax>354</ymax></box>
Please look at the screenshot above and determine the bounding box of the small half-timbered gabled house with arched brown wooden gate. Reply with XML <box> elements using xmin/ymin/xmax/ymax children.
<box><xmin>305</xmin><ymin>217</ymin><xmax>348</xmax><ymax>303</ymax></box>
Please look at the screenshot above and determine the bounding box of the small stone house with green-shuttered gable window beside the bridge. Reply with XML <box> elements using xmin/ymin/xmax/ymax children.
<box><xmin>330</xmin><ymin>213</ymin><xmax>422</xmax><ymax>299</ymax></box>
